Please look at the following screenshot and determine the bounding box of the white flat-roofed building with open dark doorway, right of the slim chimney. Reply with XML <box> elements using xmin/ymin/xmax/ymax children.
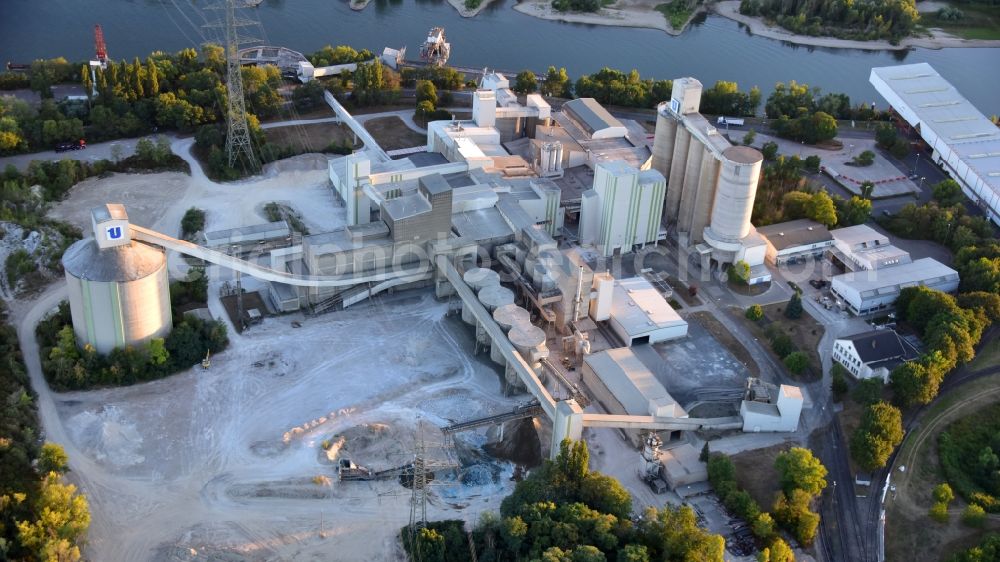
<box><xmin>609</xmin><ymin>277</ymin><xmax>687</xmax><ymax>346</ymax></box>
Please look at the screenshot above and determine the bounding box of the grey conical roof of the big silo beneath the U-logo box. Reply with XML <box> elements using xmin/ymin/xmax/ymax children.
<box><xmin>63</xmin><ymin>238</ymin><xmax>166</xmax><ymax>283</ymax></box>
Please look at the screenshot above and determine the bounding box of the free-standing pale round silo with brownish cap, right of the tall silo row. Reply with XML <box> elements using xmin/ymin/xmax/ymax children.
<box><xmin>710</xmin><ymin>146</ymin><xmax>764</xmax><ymax>241</ymax></box>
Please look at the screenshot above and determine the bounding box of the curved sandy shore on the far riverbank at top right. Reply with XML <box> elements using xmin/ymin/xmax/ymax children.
<box><xmin>712</xmin><ymin>0</ymin><xmax>1000</xmax><ymax>51</ymax></box>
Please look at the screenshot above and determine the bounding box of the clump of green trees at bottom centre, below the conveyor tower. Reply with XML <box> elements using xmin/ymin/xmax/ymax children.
<box><xmin>400</xmin><ymin>440</ymin><xmax>732</xmax><ymax>562</ymax></box>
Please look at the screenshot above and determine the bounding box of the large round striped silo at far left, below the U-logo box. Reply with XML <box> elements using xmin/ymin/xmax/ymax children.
<box><xmin>62</xmin><ymin>238</ymin><xmax>173</xmax><ymax>354</ymax></box>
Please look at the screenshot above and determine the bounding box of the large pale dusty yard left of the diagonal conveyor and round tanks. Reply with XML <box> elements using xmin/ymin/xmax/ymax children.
<box><xmin>57</xmin><ymin>295</ymin><xmax>514</xmax><ymax>560</ymax></box>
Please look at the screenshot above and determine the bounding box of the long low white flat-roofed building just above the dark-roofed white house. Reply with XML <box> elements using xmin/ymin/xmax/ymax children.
<box><xmin>830</xmin><ymin>258</ymin><xmax>959</xmax><ymax>315</ymax></box>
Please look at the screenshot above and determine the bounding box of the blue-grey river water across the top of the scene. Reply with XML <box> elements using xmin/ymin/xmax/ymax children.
<box><xmin>0</xmin><ymin>0</ymin><xmax>1000</xmax><ymax>115</ymax></box>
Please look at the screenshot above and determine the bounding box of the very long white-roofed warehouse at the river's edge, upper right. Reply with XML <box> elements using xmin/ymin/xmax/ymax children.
<box><xmin>868</xmin><ymin>62</ymin><xmax>1000</xmax><ymax>224</ymax></box>
